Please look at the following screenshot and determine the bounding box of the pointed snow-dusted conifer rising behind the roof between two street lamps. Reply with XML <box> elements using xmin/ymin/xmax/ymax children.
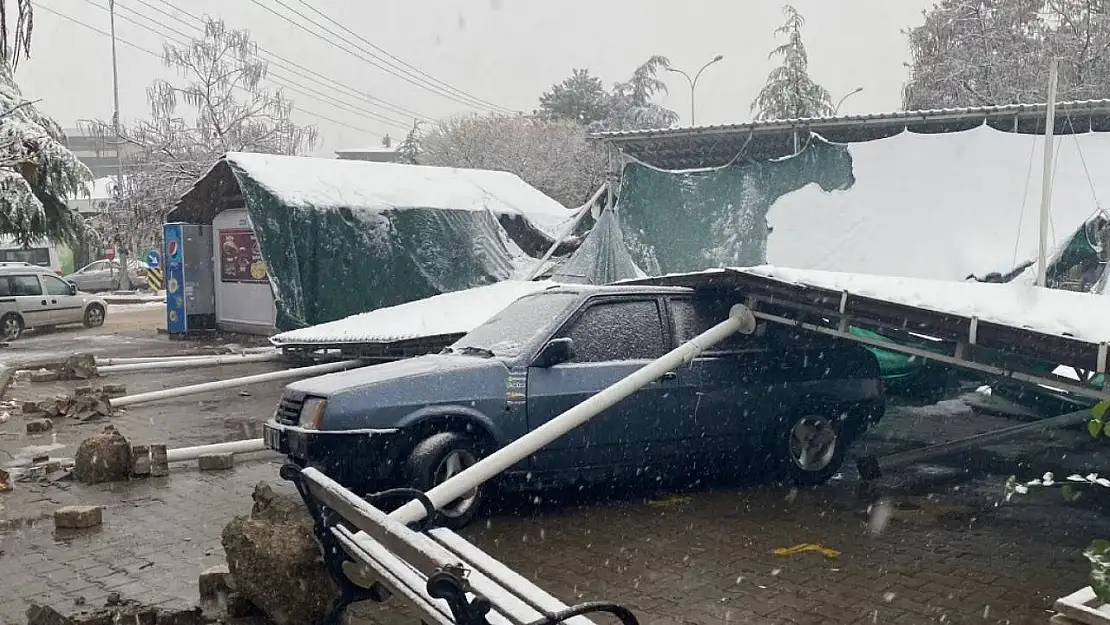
<box><xmin>751</xmin><ymin>4</ymin><xmax>833</xmax><ymax>120</ymax></box>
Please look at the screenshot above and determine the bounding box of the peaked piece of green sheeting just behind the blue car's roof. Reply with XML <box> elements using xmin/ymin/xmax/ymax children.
<box><xmin>552</xmin><ymin>209</ymin><xmax>645</xmax><ymax>284</ymax></box>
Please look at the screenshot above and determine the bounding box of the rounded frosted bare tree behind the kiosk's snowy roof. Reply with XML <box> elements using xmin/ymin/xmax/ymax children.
<box><xmin>420</xmin><ymin>114</ymin><xmax>605</xmax><ymax>206</ymax></box>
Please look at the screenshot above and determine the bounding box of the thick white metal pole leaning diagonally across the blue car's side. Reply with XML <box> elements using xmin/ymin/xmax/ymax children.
<box><xmin>390</xmin><ymin>304</ymin><xmax>756</xmax><ymax>524</ymax></box>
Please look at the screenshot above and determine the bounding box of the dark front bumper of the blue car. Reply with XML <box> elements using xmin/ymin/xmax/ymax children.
<box><xmin>262</xmin><ymin>420</ymin><xmax>404</xmax><ymax>491</ymax></box>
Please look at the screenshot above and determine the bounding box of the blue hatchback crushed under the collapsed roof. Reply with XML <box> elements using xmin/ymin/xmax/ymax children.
<box><xmin>264</xmin><ymin>285</ymin><xmax>886</xmax><ymax>527</ymax></box>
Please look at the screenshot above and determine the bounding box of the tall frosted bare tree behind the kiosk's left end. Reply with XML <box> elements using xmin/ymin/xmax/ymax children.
<box><xmin>86</xmin><ymin>18</ymin><xmax>316</xmax><ymax>286</ymax></box>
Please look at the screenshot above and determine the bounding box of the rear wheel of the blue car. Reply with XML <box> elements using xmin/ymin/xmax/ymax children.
<box><xmin>775</xmin><ymin>409</ymin><xmax>857</xmax><ymax>486</ymax></box>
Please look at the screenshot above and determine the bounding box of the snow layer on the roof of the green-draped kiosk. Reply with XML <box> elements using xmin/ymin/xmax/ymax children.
<box><xmin>225</xmin><ymin>152</ymin><xmax>572</xmax><ymax>233</ymax></box>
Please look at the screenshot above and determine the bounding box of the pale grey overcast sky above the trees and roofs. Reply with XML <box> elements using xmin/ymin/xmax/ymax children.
<box><xmin>17</xmin><ymin>0</ymin><xmax>930</xmax><ymax>155</ymax></box>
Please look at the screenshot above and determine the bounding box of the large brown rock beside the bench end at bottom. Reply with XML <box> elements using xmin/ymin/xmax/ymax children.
<box><xmin>222</xmin><ymin>482</ymin><xmax>339</xmax><ymax>625</ymax></box>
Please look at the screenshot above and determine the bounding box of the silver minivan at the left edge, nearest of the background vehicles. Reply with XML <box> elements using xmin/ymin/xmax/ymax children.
<box><xmin>0</xmin><ymin>263</ymin><xmax>108</xmax><ymax>341</ymax></box>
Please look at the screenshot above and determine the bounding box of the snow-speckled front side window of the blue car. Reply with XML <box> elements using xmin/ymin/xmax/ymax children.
<box><xmin>563</xmin><ymin>300</ymin><xmax>667</xmax><ymax>362</ymax></box>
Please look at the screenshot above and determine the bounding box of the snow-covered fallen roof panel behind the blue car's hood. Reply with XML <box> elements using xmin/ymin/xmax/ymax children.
<box><xmin>270</xmin><ymin>280</ymin><xmax>555</xmax><ymax>345</ymax></box>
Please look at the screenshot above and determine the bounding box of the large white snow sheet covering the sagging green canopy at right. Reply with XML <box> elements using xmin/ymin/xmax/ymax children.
<box><xmin>767</xmin><ymin>125</ymin><xmax>1110</xmax><ymax>280</ymax></box>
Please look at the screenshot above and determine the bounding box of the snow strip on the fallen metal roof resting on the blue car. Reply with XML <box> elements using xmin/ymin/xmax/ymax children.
<box><xmin>736</xmin><ymin>265</ymin><xmax>1110</xmax><ymax>343</ymax></box>
